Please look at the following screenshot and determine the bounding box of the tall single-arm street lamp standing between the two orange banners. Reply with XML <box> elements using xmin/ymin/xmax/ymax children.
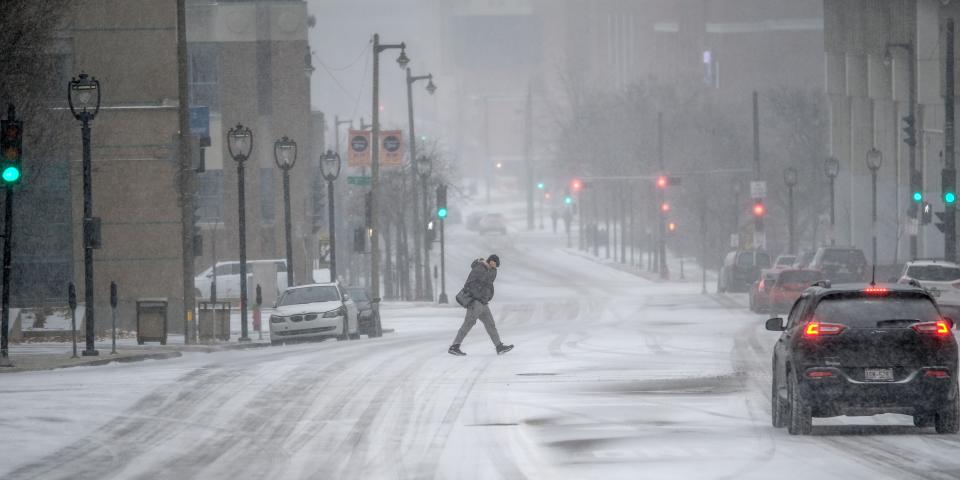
<box><xmin>370</xmin><ymin>34</ymin><xmax>410</xmax><ymax>304</ymax></box>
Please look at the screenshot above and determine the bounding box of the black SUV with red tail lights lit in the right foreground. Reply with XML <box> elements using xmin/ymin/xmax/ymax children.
<box><xmin>766</xmin><ymin>281</ymin><xmax>960</xmax><ymax>435</ymax></box>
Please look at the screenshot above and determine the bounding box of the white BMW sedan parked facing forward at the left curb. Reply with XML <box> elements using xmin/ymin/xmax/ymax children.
<box><xmin>270</xmin><ymin>283</ymin><xmax>360</xmax><ymax>345</ymax></box>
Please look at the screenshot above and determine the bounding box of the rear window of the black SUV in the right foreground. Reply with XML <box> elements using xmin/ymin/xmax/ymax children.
<box><xmin>813</xmin><ymin>295</ymin><xmax>940</xmax><ymax>328</ymax></box>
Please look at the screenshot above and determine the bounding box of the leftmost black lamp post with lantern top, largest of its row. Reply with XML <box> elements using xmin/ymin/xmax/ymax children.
<box><xmin>67</xmin><ymin>73</ymin><xmax>101</xmax><ymax>356</ymax></box>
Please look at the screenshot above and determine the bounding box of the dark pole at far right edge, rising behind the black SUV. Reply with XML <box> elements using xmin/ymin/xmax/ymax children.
<box><xmin>941</xmin><ymin>18</ymin><xmax>957</xmax><ymax>262</ymax></box>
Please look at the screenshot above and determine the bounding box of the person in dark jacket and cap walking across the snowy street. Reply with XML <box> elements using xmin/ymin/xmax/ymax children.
<box><xmin>447</xmin><ymin>254</ymin><xmax>513</xmax><ymax>356</ymax></box>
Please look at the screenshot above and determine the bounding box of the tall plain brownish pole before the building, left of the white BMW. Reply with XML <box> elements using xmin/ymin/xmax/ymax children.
<box><xmin>177</xmin><ymin>0</ymin><xmax>195</xmax><ymax>344</ymax></box>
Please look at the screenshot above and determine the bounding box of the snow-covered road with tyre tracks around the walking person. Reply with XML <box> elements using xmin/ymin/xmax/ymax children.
<box><xmin>0</xmin><ymin>207</ymin><xmax>960</xmax><ymax>480</ymax></box>
